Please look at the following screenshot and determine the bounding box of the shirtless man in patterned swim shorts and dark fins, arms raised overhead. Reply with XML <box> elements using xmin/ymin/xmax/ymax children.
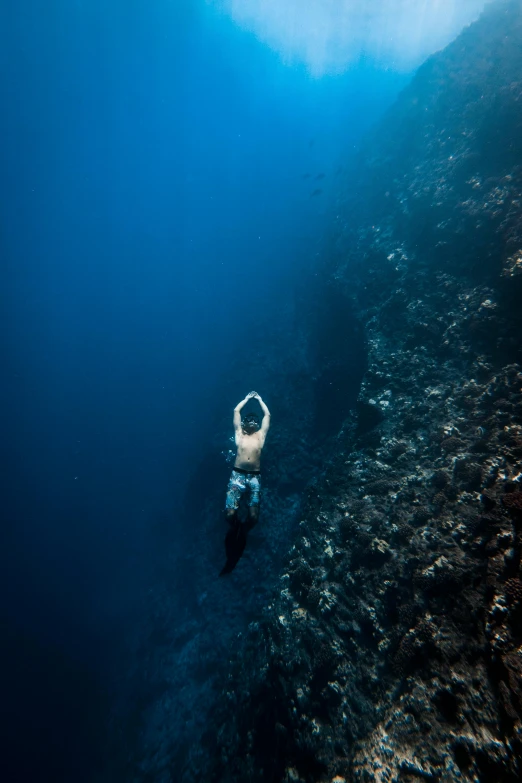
<box><xmin>220</xmin><ymin>392</ymin><xmax>270</xmax><ymax>576</ymax></box>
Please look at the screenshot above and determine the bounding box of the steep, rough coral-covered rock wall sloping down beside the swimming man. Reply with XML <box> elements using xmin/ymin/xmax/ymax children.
<box><xmin>205</xmin><ymin>2</ymin><xmax>522</xmax><ymax>783</ymax></box>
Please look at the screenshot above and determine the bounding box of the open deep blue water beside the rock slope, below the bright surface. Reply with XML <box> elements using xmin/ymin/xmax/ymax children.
<box><xmin>0</xmin><ymin>0</ymin><xmax>484</xmax><ymax>783</ymax></box>
